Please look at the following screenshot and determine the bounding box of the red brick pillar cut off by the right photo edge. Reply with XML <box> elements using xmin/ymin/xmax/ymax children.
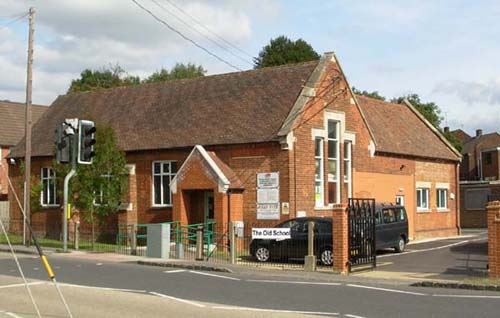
<box><xmin>486</xmin><ymin>201</ymin><xmax>500</xmax><ymax>278</ymax></box>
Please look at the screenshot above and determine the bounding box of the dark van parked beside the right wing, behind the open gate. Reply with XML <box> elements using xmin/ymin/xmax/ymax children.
<box><xmin>375</xmin><ymin>205</ymin><xmax>408</xmax><ymax>253</ymax></box>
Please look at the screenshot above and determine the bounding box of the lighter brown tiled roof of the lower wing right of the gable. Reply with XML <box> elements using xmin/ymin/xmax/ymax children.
<box><xmin>356</xmin><ymin>95</ymin><xmax>459</xmax><ymax>160</ymax></box>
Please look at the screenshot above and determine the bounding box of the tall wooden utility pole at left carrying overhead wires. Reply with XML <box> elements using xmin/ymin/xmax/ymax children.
<box><xmin>23</xmin><ymin>7</ymin><xmax>35</xmax><ymax>246</ymax></box>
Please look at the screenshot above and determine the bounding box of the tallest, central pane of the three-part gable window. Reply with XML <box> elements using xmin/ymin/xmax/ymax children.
<box><xmin>328</xmin><ymin>120</ymin><xmax>340</xmax><ymax>203</ymax></box>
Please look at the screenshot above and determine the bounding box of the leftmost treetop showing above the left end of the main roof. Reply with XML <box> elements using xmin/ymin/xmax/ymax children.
<box><xmin>68</xmin><ymin>65</ymin><xmax>141</xmax><ymax>93</ymax></box>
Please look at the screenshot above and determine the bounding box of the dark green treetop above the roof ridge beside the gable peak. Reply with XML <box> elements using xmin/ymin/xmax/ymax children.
<box><xmin>254</xmin><ymin>35</ymin><xmax>320</xmax><ymax>69</ymax></box>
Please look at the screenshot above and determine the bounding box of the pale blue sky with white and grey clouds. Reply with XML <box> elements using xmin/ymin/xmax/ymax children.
<box><xmin>0</xmin><ymin>0</ymin><xmax>500</xmax><ymax>134</ymax></box>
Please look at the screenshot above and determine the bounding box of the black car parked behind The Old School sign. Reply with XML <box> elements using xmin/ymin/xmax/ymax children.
<box><xmin>250</xmin><ymin>217</ymin><xmax>332</xmax><ymax>266</ymax></box>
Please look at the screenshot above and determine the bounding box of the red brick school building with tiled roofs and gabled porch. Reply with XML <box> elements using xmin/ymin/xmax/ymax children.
<box><xmin>6</xmin><ymin>53</ymin><xmax>460</xmax><ymax>238</ymax></box>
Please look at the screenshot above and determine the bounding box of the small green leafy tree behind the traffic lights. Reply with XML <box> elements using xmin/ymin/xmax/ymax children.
<box><xmin>55</xmin><ymin>124</ymin><xmax>127</xmax><ymax>243</ymax></box>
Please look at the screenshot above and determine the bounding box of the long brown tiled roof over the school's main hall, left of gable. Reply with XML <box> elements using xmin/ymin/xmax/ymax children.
<box><xmin>11</xmin><ymin>61</ymin><xmax>318</xmax><ymax>157</ymax></box>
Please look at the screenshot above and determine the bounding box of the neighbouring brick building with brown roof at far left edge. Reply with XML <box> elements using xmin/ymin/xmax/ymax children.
<box><xmin>0</xmin><ymin>101</ymin><xmax>48</xmax><ymax>201</ymax></box>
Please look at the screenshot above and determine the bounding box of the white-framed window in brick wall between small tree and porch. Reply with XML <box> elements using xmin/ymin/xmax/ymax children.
<box><xmin>153</xmin><ymin>161</ymin><xmax>177</xmax><ymax>206</ymax></box>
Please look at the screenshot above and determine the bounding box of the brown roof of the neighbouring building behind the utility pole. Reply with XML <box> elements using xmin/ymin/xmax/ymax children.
<box><xmin>0</xmin><ymin>101</ymin><xmax>48</xmax><ymax>146</ymax></box>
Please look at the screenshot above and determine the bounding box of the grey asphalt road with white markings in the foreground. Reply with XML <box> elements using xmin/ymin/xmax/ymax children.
<box><xmin>0</xmin><ymin>231</ymin><xmax>500</xmax><ymax>318</ymax></box>
